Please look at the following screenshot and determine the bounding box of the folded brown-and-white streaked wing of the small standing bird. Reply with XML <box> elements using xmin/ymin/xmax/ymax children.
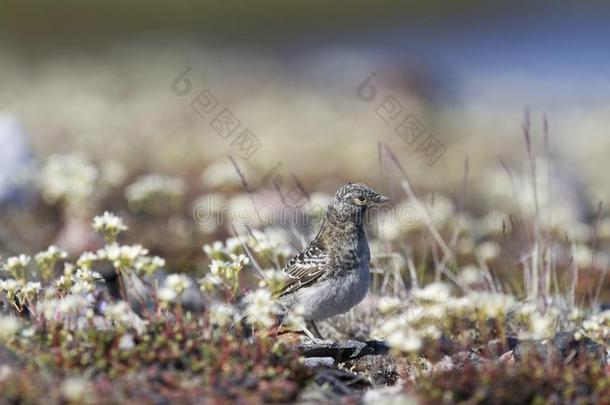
<box><xmin>274</xmin><ymin>244</ymin><xmax>328</xmax><ymax>297</ymax></box>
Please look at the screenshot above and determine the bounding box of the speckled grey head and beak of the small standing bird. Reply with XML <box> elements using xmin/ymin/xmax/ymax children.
<box><xmin>328</xmin><ymin>183</ymin><xmax>389</xmax><ymax>221</ymax></box>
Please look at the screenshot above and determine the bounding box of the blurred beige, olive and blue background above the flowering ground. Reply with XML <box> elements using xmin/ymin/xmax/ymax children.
<box><xmin>0</xmin><ymin>0</ymin><xmax>610</xmax><ymax>294</ymax></box>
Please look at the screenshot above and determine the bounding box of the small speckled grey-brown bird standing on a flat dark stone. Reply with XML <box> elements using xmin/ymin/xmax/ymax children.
<box><xmin>274</xmin><ymin>183</ymin><xmax>389</xmax><ymax>340</ymax></box>
